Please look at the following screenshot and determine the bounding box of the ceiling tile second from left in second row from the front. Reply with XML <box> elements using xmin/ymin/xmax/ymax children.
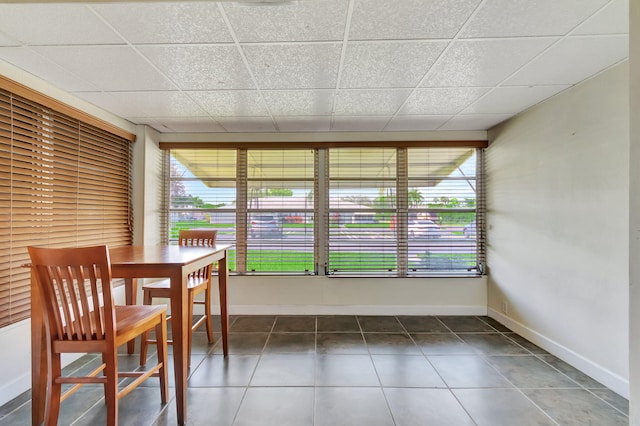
<box><xmin>34</xmin><ymin>46</ymin><xmax>175</xmax><ymax>90</ymax></box>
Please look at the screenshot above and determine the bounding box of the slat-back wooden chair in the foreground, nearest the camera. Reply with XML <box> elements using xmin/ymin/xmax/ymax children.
<box><xmin>28</xmin><ymin>246</ymin><xmax>168</xmax><ymax>425</ymax></box>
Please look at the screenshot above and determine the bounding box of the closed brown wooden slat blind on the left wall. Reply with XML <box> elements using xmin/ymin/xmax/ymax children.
<box><xmin>0</xmin><ymin>85</ymin><xmax>132</xmax><ymax>327</ymax></box>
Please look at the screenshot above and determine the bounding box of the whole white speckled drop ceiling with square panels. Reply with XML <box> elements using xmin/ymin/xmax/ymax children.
<box><xmin>0</xmin><ymin>0</ymin><xmax>629</xmax><ymax>133</ymax></box>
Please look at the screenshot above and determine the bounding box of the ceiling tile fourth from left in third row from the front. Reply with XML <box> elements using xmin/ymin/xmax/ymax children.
<box><xmin>262</xmin><ymin>90</ymin><xmax>335</xmax><ymax>116</ymax></box>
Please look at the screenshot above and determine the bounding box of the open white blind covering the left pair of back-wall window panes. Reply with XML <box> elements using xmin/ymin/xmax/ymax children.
<box><xmin>169</xmin><ymin>149</ymin><xmax>315</xmax><ymax>274</ymax></box>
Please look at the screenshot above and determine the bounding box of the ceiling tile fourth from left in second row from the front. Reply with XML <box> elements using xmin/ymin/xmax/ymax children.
<box><xmin>243</xmin><ymin>43</ymin><xmax>342</xmax><ymax>89</ymax></box>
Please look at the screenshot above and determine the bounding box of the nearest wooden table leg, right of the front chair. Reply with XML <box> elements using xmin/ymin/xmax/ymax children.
<box><xmin>170</xmin><ymin>274</ymin><xmax>191</xmax><ymax>425</ymax></box>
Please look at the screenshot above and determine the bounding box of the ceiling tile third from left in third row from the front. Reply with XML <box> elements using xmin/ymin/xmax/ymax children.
<box><xmin>187</xmin><ymin>90</ymin><xmax>269</xmax><ymax>117</ymax></box>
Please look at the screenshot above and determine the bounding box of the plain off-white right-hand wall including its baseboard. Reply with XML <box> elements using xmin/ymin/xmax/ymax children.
<box><xmin>486</xmin><ymin>62</ymin><xmax>629</xmax><ymax>396</ymax></box>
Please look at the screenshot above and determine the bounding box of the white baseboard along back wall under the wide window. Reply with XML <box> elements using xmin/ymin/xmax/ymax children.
<box><xmin>224</xmin><ymin>305</ymin><xmax>487</xmax><ymax>315</ymax></box>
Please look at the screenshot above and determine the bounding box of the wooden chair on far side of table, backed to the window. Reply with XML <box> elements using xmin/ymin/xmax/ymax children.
<box><xmin>140</xmin><ymin>229</ymin><xmax>218</xmax><ymax>366</ymax></box>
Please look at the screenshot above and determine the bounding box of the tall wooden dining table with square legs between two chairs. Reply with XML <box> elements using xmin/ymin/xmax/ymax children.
<box><xmin>31</xmin><ymin>244</ymin><xmax>231</xmax><ymax>425</ymax></box>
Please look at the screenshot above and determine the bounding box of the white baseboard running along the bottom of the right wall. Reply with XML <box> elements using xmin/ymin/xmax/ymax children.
<box><xmin>488</xmin><ymin>308</ymin><xmax>629</xmax><ymax>399</ymax></box>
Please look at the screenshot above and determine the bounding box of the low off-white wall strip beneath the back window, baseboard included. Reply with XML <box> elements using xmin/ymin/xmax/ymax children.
<box><xmin>213</xmin><ymin>276</ymin><xmax>487</xmax><ymax>315</ymax></box>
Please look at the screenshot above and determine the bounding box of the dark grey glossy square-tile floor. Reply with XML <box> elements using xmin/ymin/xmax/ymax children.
<box><xmin>0</xmin><ymin>316</ymin><xmax>628</xmax><ymax>426</ymax></box>
